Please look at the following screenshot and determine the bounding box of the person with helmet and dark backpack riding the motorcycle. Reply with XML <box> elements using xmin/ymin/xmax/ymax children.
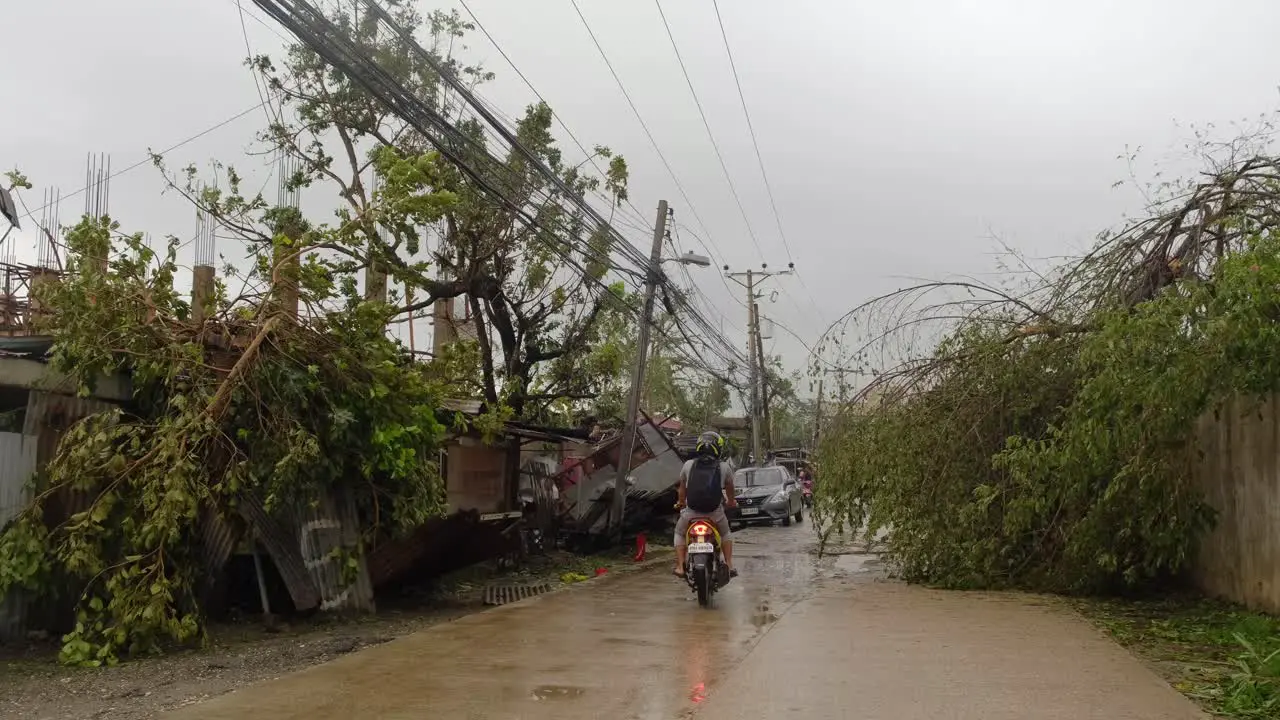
<box><xmin>675</xmin><ymin>430</ymin><xmax>737</xmax><ymax>578</ymax></box>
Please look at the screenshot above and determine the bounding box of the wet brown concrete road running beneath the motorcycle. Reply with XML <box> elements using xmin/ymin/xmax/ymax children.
<box><xmin>168</xmin><ymin>524</ymin><xmax>1202</xmax><ymax>720</ymax></box>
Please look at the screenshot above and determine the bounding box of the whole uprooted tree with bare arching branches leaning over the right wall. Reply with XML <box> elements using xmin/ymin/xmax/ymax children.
<box><xmin>818</xmin><ymin>148</ymin><xmax>1280</xmax><ymax>592</ymax></box>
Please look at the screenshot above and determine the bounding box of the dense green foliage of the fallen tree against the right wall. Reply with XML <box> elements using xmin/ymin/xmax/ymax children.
<box><xmin>817</xmin><ymin>234</ymin><xmax>1280</xmax><ymax>592</ymax></box>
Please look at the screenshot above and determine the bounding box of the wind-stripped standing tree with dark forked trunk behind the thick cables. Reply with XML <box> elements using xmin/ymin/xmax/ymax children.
<box><xmin>235</xmin><ymin>3</ymin><xmax>627</xmax><ymax>420</ymax></box>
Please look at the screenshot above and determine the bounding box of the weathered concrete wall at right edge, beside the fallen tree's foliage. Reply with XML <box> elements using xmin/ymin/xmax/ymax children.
<box><xmin>1192</xmin><ymin>396</ymin><xmax>1280</xmax><ymax>612</ymax></box>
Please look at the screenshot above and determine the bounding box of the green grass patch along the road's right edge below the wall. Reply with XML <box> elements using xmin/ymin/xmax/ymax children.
<box><xmin>1078</xmin><ymin>596</ymin><xmax>1280</xmax><ymax>720</ymax></box>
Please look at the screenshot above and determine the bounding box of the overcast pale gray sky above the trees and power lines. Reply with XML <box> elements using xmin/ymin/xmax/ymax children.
<box><xmin>0</xmin><ymin>0</ymin><xmax>1280</xmax><ymax>379</ymax></box>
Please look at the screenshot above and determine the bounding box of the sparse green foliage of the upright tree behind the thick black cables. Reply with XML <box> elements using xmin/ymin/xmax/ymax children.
<box><xmin>244</xmin><ymin>3</ymin><xmax>628</xmax><ymax>420</ymax></box>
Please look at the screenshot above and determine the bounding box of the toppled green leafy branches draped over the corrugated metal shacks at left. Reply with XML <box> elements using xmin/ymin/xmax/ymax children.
<box><xmin>0</xmin><ymin>218</ymin><xmax>444</xmax><ymax>666</ymax></box>
